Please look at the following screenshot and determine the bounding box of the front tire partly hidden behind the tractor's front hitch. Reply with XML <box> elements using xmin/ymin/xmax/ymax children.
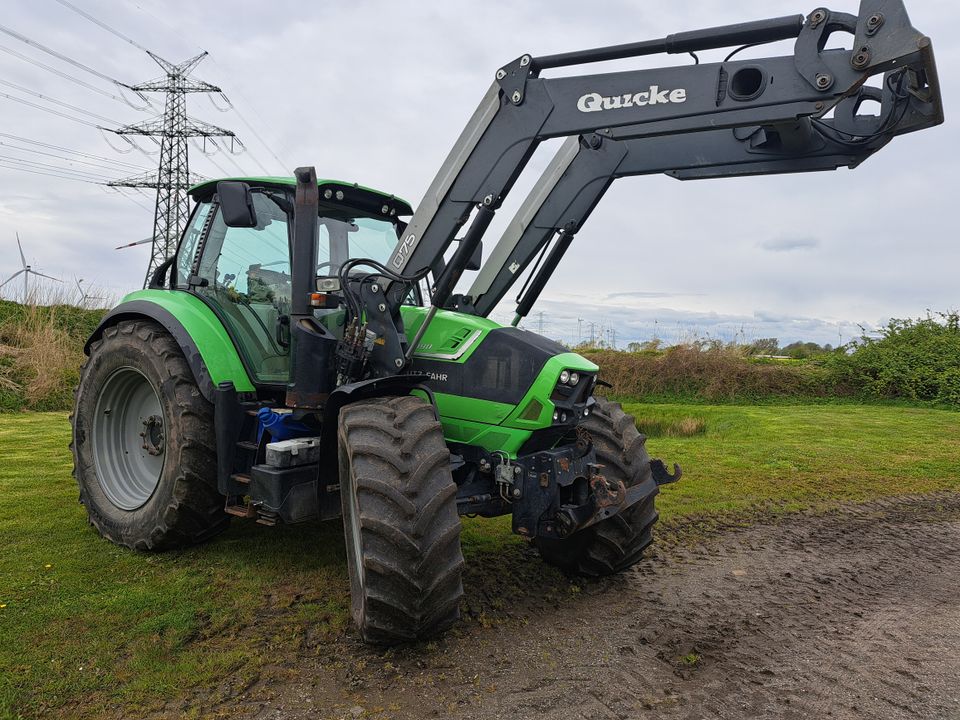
<box><xmin>536</xmin><ymin>398</ymin><xmax>657</xmax><ymax>577</ymax></box>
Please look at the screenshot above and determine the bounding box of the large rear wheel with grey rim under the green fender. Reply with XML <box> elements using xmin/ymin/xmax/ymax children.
<box><xmin>70</xmin><ymin>320</ymin><xmax>229</xmax><ymax>550</ymax></box>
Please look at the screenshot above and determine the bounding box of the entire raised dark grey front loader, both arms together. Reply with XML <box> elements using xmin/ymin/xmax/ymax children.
<box><xmin>371</xmin><ymin>0</ymin><xmax>943</xmax><ymax>365</ymax></box>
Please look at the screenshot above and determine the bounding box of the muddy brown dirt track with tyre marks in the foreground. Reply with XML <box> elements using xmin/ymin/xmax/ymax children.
<box><xmin>211</xmin><ymin>494</ymin><xmax>960</xmax><ymax>719</ymax></box>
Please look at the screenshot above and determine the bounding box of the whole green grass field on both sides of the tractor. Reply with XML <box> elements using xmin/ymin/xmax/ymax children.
<box><xmin>0</xmin><ymin>403</ymin><xmax>960</xmax><ymax>718</ymax></box>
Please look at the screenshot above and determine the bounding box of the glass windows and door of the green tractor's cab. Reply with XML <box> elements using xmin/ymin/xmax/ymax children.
<box><xmin>178</xmin><ymin>178</ymin><xmax>412</xmax><ymax>385</ymax></box>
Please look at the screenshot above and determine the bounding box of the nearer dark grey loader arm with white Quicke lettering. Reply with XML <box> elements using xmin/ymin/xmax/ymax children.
<box><xmin>367</xmin><ymin>0</ymin><xmax>942</xmax><ymax>374</ymax></box>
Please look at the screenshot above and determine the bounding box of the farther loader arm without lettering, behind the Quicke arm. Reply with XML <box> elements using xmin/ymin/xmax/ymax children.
<box><xmin>468</xmin><ymin>65</ymin><xmax>939</xmax><ymax>325</ymax></box>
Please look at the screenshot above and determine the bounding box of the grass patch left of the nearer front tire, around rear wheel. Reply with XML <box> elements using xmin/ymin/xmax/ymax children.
<box><xmin>0</xmin><ymin>413</ymin><xmax>349</xmax><ymax>718</ymax></box>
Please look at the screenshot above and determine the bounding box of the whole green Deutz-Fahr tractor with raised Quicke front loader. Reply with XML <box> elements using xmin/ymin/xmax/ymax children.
<box><xmin>73</xmin><ymin>0</ymin><xmax>943</xmax><ymax>644</ymax></box>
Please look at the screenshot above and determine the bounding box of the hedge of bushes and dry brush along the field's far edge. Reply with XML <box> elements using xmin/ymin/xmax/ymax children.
<box><xmin>0</xmin><ymin>292</ymin><xmax>960</xmax><ymax>410</ymax></box>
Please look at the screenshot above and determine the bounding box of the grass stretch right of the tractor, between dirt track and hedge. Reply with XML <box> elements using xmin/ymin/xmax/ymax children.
<box><xmin>624</xmin><ymin>403</ymin><xmax>960</xmax><ymax>519</ymax></box>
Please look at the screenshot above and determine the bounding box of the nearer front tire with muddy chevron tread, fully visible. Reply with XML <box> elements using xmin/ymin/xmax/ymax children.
<box><xmin>339</xmin><ymin>396</ymin><xmax>463</xmax><ymax>645</ymax></box>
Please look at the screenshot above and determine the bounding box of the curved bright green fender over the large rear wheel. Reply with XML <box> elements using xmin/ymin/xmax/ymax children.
<box><xmin>83</xmin><ymin>290</ymin><xmax>254</xmax><ymax>402</ymax></box>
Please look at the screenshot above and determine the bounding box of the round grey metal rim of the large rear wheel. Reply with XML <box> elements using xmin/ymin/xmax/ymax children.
<box><xmin>91</xmin><ymin>367</ymin><xmax>167</xmax><ymax>510</ymax></box>
